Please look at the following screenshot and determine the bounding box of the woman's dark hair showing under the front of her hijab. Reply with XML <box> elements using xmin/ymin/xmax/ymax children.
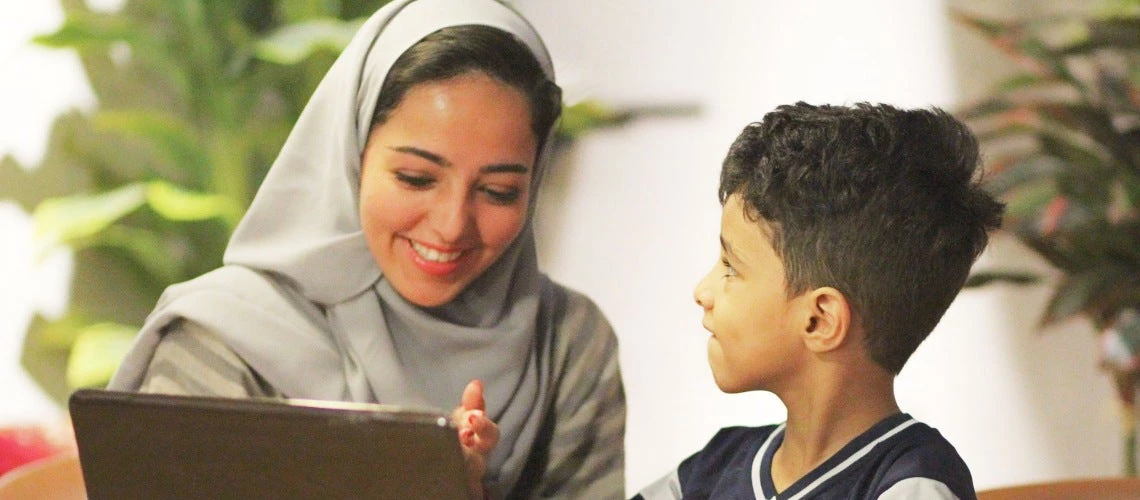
<box><xmin>372</xmin><ymin>25</ymin><xmax>562</xmax><ymax>150</ymax></box>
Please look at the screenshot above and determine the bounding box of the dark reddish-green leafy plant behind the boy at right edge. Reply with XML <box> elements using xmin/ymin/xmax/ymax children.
<box><xmin>954</xmin><ymin>0</ymin><xmax>1140</xmax><ymax>475</ymax></box>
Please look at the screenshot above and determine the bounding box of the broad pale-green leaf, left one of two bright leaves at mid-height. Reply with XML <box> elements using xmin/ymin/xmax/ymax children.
<box><xmin>32</xmin><ymin>183</ymin><xmax>146</xmax><ymax>252</ymax></box>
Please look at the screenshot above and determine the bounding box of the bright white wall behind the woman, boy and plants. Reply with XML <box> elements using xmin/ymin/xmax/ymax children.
<box><xmin>0</xmin><ymin>0</ymin><xmax>1119</xmax><ymax>491</ymax></box>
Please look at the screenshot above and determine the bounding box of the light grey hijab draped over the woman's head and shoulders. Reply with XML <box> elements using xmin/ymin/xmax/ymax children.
<box><xmin>108</xmin><ymin>0</ymin><xmax>554</xmax><ymax>492</ymax></box>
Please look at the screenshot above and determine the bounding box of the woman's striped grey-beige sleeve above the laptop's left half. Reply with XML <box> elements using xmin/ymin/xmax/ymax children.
<box><xmin>139</xmin><ymin>320</ymin><xmax>280</xmax><ymax>397</ymax></box>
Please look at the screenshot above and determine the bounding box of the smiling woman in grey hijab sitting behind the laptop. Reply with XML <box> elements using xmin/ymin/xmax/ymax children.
<box><xmin>109</xmin><ymin>0</ymin><xmax>625</xmax><ymax>498</ymax></box>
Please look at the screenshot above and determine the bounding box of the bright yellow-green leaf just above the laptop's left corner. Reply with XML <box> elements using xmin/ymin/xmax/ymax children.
<box><xmin>66</xmin><ymin>322</ymin><xmax>138</xmax><ymax>387</ymax></box>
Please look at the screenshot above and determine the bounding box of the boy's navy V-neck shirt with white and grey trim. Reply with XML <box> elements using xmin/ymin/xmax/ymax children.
<box><xmin>643</xmin><ymin>413</ymin><xmax>975</xmax><ymax>499</ymax></box>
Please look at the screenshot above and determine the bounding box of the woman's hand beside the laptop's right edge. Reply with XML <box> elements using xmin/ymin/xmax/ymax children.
<box><xmin>451</xmin><ymin>380</ymin><xmax>499</xmax><ymax>499</ymax></box>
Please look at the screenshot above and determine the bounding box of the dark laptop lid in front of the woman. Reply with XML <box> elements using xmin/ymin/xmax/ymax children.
<box><xmin>68</xmin><ymin>390</ymin><xmax>469</xmax><ymax>500</ymax></box>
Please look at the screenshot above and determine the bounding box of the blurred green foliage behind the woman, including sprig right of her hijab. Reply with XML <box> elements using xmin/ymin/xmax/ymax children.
<box><xmin>0</xmin><ymin>0</ymin><xmax>695</xmax><ymax>401</ymax></box>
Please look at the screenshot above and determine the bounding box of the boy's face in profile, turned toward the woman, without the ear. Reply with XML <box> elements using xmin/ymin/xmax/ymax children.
<box><xmin>693</xmin><ymin>195</ymin><xmax>807</xmax><ymax>393</ymax></box>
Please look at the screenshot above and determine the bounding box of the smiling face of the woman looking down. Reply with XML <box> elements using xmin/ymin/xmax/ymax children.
<box><xmin>360</xmin><ymin>73</ymin><xmax>538</xmax><ymax>308</ymax></box>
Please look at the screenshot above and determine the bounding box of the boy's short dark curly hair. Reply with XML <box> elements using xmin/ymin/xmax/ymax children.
<box><xmin>719</xmin><ymin>103</ymin><xmax>1003</xmax><ymax>374</ymax></box>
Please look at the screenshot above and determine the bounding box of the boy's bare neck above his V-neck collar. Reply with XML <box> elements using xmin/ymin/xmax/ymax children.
<box><xmin>772</xmin><ymin>368</ymin><xmax>899</xmax><ymax>491</ymax></box>
